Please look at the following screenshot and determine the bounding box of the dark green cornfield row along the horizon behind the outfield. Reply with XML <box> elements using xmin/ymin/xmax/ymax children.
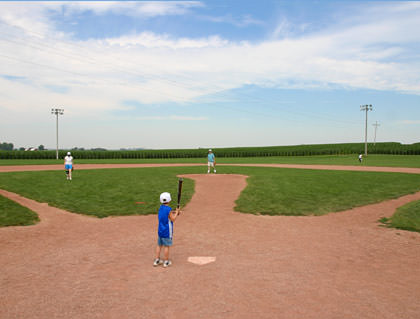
<box><xmin>0</xmin><ymin>143</ymin><xmax>420</xmax><ymax>159</ymax></box>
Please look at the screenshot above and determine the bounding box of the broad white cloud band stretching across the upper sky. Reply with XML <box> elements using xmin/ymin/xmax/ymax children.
<box><xmin>0</xmin><ymin>2</ymin><xmax>420</xmax><ymax>119</ymax></box>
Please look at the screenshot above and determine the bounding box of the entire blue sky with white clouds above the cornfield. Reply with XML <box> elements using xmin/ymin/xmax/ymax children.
<box><xmin>0</xmin><ymin>0</ymin><xmax>420</xmax><ymax>149</ymax></box>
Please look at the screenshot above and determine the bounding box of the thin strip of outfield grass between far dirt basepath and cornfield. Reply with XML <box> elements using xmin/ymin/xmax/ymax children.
<box><xmin>0</xmin><ymin>151</ymin><xmax>420</xmax><ymax>168</ymax></box>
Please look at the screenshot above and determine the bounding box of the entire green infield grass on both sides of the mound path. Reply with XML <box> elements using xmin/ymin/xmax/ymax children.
<box><xmin>0</xmin><ymin>166</ymin><xmax>420</xmax><ymax>217</ymax></box>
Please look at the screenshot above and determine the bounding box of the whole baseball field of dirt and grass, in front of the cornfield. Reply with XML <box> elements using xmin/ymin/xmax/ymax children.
<box><xmin>0</xmin><ymin>156</ymin><xmax>420</xmax><ymax>318</ymax></box>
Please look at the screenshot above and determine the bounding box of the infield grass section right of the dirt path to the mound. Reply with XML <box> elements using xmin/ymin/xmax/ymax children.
<box><xmin>224</xmin><ymin>168</ymin><xmax>420</xmax><ymax>215</ymax></box>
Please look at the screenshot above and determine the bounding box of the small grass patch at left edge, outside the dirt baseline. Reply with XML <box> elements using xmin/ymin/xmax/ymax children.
<box><xmin>0</xmin><ymin>195</ymin><xmax>39</xmax><ymax>227</ymax></box>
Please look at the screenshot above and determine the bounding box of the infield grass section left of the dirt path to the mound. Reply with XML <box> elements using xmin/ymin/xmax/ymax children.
<box><xmin>0</xmin><ymin>168</ymin><xmax>194</xmax><ymax>218</ymax></box>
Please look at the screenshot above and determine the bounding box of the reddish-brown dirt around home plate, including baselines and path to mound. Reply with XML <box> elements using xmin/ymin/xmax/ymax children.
<box><xmin>0</xmin><ymin>164</ymin><xmax>420</xmax><ymax>319</ymax></box>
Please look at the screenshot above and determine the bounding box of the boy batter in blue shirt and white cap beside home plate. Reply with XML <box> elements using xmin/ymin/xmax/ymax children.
<box><xmin>153</xmin><ymin>192</ymin><xmax>180</xmax><ymax>268</ymax></box>
